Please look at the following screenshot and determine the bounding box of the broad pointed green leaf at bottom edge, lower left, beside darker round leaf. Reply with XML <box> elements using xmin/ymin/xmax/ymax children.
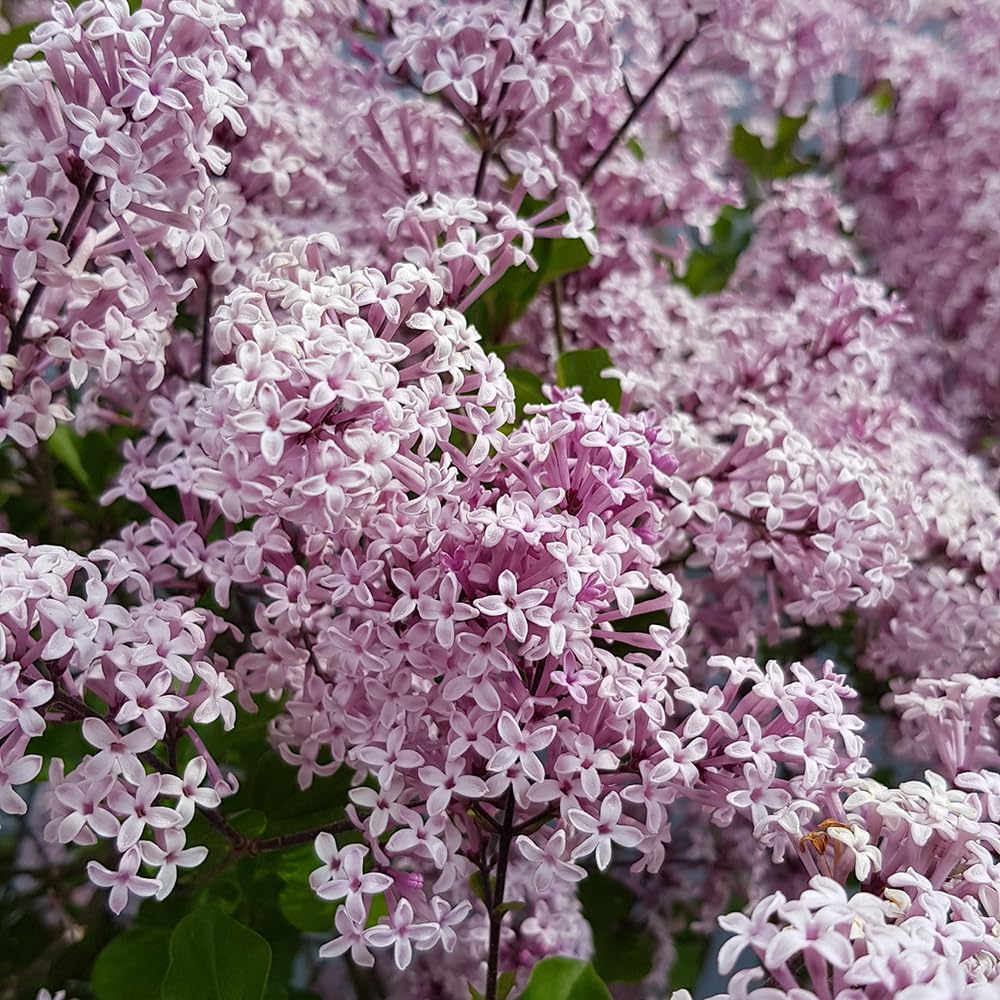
<box><xmin>163</xmin><ymin>906</ymin><xmax>271</xmax><ymax>1000</ymax></box>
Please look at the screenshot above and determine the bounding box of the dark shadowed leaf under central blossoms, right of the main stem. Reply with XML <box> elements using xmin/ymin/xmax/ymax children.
<box><xmin>577</xmin><ymin>872</ymin><xmax>654</xmax><ymax>983</ymax></box>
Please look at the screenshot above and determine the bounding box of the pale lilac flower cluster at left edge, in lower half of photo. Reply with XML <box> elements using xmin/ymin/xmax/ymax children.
<box><xmin>0</xmin><ymin>535</ymin><xmax>234</xmax><ymax>913</ymax></box>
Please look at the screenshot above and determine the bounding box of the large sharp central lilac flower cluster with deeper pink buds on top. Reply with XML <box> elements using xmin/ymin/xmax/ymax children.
<box><xmin>172</xmin><ymin>378</ymin><xmax>866</xmax><ymax>964</ymax></box>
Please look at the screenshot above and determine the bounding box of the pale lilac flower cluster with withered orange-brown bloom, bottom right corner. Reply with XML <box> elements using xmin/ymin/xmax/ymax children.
<box><xmin>719</xmin><ymin>772</ymin><xmax>1000</xmax><ymax>1000</ymax></box>
